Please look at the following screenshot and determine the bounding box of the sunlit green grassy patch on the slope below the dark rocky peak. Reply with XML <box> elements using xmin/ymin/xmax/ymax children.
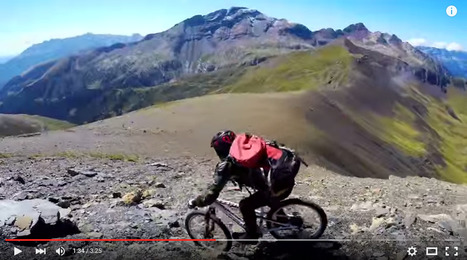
<box><xmin>224</xmin><ymin>46</ymin><xmax>352</xmax><ymax>93</ymax></box>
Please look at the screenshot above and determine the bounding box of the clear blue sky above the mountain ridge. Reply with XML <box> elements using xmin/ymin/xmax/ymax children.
<box><xmin>0</xmin><ymin>0</ymin><xmax>467</xmax><ymax>56</ymax></box>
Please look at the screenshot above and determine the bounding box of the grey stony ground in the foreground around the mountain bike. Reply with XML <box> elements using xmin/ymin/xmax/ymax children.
<box><xmin>0</xmin><ymin>156</ymin><xmax>467</xmax><ymax>260</ymax></box>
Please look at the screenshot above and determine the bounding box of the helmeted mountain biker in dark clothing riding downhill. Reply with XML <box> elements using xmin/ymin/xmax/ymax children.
<box><xmin>189</xmin><ymin>130</ymin><xmax>302</xmax><ymax>243</ymax></box>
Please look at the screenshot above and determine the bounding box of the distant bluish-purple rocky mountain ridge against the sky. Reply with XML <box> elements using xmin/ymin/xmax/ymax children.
<box><xmin>0</xmin><ymin>8</ymin><xmax>446</xmax><ymax>123</ymax></box>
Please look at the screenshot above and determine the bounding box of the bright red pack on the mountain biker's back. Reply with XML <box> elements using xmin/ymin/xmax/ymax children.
<box><xmin>230</xmin><ymin>134</ymin><xmax>283</xmax><ymax>168</ymax></box>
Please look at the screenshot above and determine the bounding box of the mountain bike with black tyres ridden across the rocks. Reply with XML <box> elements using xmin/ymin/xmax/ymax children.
<box><xmin>185</xmin><ymin>198</ymin><xmax>327</xmax><ymax>251</ymax></box>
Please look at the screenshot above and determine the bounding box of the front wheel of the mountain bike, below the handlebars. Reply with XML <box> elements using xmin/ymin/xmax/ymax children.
<box><xmin>185</xmin><ymin>211</ymin><xmax>232</xmax><ymax>251</ymax></box>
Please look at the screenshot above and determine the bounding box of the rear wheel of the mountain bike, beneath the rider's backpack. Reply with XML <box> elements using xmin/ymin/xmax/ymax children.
<box><xmin>266</xmin><ymin>199</ymin><xmax>328</xmax><ymax>239</ymax></box>
